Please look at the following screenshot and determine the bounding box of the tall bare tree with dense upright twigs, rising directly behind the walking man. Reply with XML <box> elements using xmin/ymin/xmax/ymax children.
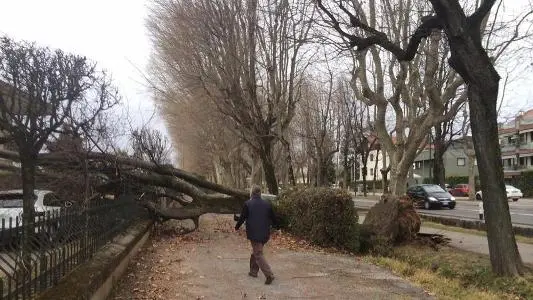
<box><xmin>148</xmin><ymin>0</ymin><xmax>315</xmax><ymax>194</ymax></box>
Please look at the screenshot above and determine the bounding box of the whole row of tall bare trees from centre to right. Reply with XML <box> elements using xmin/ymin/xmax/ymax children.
<box><xmin>148</xmin><ymin>0</ymin><xmax>531</xmax><ymax>274</ymax></box>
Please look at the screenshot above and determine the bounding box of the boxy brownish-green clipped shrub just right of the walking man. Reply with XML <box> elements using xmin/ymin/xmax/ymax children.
<box><xmin>275</xmin><ymin>188</ymin><xmax>359</xmax><ymax>252</ymax></box>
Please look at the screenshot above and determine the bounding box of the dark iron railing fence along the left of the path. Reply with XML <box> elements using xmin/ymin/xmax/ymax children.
<box><xmin>0</xmin><ymin>193</ymin><xmax>145</xmax><ymax>300</ymax></box>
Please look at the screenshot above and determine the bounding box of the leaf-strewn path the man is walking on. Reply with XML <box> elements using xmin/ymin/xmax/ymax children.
<box><xmin>111</xmin><ymin>215</ymin><xmax>431</xmax><ymax>300</ymax></box>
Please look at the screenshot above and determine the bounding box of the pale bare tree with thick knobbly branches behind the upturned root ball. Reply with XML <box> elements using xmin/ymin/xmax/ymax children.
<box><xmin>320</xmin><ymin>1</ymin><xmax>466</xmax><ymax>195</ymax></box>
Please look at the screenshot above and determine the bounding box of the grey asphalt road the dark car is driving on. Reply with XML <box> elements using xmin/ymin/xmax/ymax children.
<box><xmin>354</xmin><ymin>198</ymin><xmax>533</xmax><ymax>226</ymax></box>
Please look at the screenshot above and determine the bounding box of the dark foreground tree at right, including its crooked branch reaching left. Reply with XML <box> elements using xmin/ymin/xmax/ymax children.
<box><xmin>317</xmin><ymin>0</ymin><xmax>524</xmax><ymax>275</ymax></box>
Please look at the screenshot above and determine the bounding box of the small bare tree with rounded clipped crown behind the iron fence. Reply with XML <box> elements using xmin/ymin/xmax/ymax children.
<box><xmin>0</xmin><ymin>37</ymin><xmax>117</xmax><ymax>274</ymax></box>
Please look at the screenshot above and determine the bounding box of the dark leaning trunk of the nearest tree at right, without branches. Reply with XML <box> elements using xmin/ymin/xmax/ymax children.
<box><xmin>430</xmin><ymin>0</ymin><xmax>524</xmax><ymax>276</ymax></box>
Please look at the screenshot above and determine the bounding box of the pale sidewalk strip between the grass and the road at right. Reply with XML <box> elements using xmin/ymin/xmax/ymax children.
<box><xmin>420</xmin><ymin>226</ymin><xmax>533</xmax><ymax>264</ymax></box>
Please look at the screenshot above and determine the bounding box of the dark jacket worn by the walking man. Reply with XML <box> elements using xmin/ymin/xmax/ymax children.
<box><xmin>235</xmin><ymin>195</ymin><xmax>276</xmax><ymax>244</ymax></box>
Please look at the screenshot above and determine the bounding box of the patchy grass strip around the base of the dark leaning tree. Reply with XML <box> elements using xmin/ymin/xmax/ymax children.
<box><xmin>364</xmin><ymin>245</ymin><xmax>533</xmax><ymax>299</ymax></box>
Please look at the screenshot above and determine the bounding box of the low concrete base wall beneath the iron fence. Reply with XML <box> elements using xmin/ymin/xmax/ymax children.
<box><xmin>35</xmin><ymin>221</ymin><xmax>153</xmax><ymax>300</ymax></box>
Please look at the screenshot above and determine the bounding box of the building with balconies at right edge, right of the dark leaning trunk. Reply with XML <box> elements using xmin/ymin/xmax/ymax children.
<box><xmin>498</xmin><ymin>109</ymin><xmax>533</xmax><ymax>179</ymax></box>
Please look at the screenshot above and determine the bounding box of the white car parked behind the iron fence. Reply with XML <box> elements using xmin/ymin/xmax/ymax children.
<box><xmin>0</xmin><ymin>190</ymin><xmax>71</xmax><ymax>245</ymax></box>
